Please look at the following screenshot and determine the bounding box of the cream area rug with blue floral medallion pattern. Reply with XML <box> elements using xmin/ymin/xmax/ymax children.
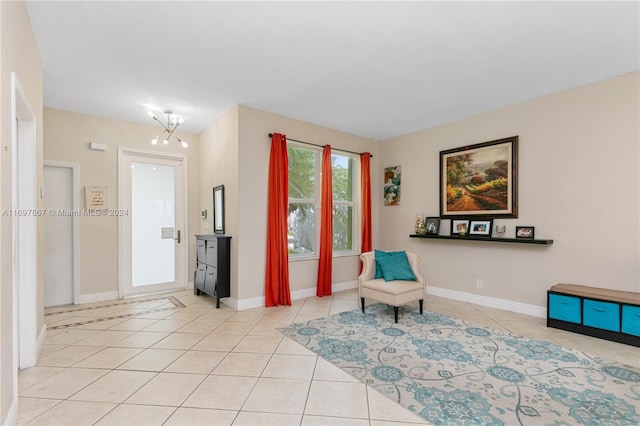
<box><xmin>279</xmin><ymin>303</ymin><xmax>640</xmax><ymax>425</ymax></box>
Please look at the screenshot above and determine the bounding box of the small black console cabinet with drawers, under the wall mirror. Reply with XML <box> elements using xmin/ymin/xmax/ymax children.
<box><xmin>193</xmin><ymin>235</ymin><xmax>231</xmax><ymax>308</ymax></box>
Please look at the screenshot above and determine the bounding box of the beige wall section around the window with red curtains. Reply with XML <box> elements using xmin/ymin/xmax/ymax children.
<box><xmin>234</xmin><ymin>106</ymin><xmax>381</xmax><ymax>301</ymax></box>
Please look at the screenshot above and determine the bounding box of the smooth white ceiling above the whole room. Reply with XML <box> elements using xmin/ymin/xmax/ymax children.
<box><xmin>27</xmin><ymin>0</ymin><xmax>640</xmax><ymax>140</ymax></box>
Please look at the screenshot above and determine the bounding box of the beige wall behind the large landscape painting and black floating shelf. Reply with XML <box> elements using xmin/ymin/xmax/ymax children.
<box><xmin>377</xmin><ymin>72</ymin><xmax>640</xmax><ymax>307</ymax></box>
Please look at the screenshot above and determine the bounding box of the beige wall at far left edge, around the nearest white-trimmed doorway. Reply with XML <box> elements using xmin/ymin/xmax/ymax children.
<box><xmin>0</xmin><ymin>1</ymin><xmax>44</xmax><ymax>424</ymax></box>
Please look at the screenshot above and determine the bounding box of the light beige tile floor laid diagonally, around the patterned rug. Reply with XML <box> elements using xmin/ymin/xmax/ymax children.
<box><xmin>18</xmin><ymin>290</ymin><xmax>640</xmax><ymax>426</ymax></box>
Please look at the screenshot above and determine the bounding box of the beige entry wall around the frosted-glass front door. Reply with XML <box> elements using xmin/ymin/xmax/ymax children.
<box><xmin>44</xmin><ymin>108</ymin><xmax>200</xmax><ymax>299</ymax></box>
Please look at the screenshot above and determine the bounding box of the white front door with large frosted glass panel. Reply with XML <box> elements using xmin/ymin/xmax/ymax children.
<box><xmin>118</xmin><ymin>149</ymin><xmax>188</xmax><ymax>296</ymax></box>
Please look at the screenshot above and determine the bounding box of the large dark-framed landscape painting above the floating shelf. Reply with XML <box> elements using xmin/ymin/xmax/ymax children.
<box><xmin>440</xmin><ymin>136</ymin><xmax>518</xmax><ymax>218</ymax></box>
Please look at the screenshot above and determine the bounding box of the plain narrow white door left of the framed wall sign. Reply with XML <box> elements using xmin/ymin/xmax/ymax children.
<box><xmin>44</xmin><ymin>165</ymin><xmax>76</xmax><ymax>307</ymax></box>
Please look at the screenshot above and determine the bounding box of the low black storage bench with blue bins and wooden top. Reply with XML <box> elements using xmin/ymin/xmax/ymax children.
<box><xmin>547</xmin><ymin>284</ymin><xmax>640</xmax><ymax>347</ymax></box>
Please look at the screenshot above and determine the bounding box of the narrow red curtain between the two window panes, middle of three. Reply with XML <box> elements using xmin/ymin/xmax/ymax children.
<box><xmin>316</xmin><ymin>145</ymin><xmax>333</xmax><ymax>297</ymax></box>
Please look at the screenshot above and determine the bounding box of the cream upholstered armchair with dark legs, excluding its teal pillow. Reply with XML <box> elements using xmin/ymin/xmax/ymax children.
<box><xmin>358</xmin><ymin>251</ymin><xmax>427</xmax><ymax>323</ymax></box>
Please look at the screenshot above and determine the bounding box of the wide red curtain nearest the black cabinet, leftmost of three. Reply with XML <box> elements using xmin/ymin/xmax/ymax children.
<box><xmin>264</xmin><ymin>133</ymin><xmax>291</xmax><ymax>307</ymax></box>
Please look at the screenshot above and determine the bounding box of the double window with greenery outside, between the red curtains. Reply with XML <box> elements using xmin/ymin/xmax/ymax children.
<box><xmin>287</xmin><ymin>143</ymin><xmax>355</xmax><ymax>257</ymax></box>
